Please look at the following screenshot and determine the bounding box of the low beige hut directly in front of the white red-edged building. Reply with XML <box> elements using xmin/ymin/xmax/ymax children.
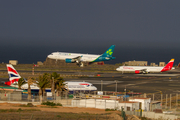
<box><xmin>118</xmin><ymin>101</ymin><xmax>140</xmax><ymax>111</ymax></box>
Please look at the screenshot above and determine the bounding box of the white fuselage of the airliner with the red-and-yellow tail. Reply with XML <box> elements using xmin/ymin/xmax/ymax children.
<box><xmin>116</xmin><ymin>66</ymin><xmax>164</xmax><ymax>72</ymax></box>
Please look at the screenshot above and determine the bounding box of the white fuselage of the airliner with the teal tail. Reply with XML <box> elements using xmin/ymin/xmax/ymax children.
<box><xmin>48</xmin><ymin>52</ymin><xmax>100</xmax><ymax>62</ymax></box>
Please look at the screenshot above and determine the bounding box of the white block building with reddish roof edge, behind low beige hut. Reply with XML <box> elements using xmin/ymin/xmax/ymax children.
<box><xmin>129</xmin><ymin>98</ymin><xmax>151</xmax><ymax>111</ymax></box>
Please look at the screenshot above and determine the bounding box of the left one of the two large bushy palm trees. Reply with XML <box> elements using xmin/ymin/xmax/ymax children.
<box><xmin>37</xmin><ymin>73</ymin><xmax>50</xmax><ymax>97</ymax></box>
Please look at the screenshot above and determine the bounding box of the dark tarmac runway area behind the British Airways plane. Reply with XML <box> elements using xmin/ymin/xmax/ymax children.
<box><xmin>0</xmin><ymin>70</ymin><xmax>180</xmax><ymax>93</ymax></box>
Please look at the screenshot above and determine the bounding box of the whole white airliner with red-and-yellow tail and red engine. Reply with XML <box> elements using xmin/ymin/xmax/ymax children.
<box><xmin>116</xmin><ymin>59</ymin><xmax>174</xmax><ymax>74</ymax></box>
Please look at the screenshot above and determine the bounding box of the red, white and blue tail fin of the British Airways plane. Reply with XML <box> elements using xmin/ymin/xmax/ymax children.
<box><xmin>5</xmin><ymin>64</ymin><xmax>21</xmax><ymax>86</ymax></box>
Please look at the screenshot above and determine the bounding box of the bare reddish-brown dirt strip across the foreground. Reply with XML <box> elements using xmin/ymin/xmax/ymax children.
<box><xmin>0</xmin><ymin>103</ymin><xmax>141</xmax><ymax>120</ymax></box>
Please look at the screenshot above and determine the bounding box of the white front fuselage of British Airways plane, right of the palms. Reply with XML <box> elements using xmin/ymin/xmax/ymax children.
<box><xmin>64</xmin><ymin>81</ymin><xmax>97</xmax><ymax>91</ymax></box>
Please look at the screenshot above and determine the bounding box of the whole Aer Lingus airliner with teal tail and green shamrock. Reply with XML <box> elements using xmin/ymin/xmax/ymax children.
<box><xmin>48</xmin><ymin>45</ymin><xmax>115</xmax><ymax>67</ymax></box>
